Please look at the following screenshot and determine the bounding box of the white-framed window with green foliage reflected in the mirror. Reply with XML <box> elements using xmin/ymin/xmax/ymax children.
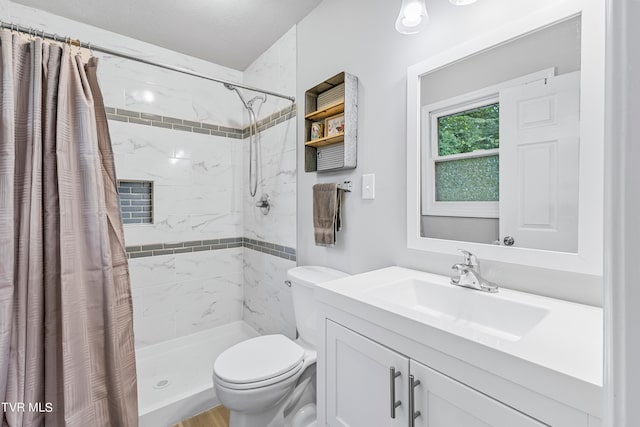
<box><xmin>423</xmin><ymin>97</ymin><xmax>500</xmax><ymax>218</ymax></box>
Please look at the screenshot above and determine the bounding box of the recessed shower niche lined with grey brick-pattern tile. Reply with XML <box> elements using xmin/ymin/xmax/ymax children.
<box><xmin>118</xmin><ymin>180</ymin><xmax>153</xmax><ymax>224</ymax></box>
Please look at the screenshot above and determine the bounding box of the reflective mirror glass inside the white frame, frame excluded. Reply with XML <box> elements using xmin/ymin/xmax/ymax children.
<box><xmin>420</xmin><ymin>16</ymin><xmax>581</xmax><ymax>252</ymax></box>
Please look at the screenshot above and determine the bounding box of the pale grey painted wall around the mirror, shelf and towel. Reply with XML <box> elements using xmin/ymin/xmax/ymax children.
<box><xmin>297</xmin><ymin>0</ymin><xmax>602</xmax><ymax>305</ymax></box>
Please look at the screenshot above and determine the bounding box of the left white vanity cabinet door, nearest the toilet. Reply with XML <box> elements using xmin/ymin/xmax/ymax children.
<box><xmin>326</xmin><ymin>320</ymin><xmax>409</xmax><ymax>427</ymax></box>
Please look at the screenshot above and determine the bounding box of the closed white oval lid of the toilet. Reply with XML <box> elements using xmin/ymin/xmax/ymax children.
<box><xmin>213</xmin><ymin>335</ymin><xmax>304</xmax><ymax>384</ymax></box>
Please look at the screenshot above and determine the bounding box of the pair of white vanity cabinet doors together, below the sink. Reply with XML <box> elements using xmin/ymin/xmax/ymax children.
<box><xmin>326</xmin><ymin>320</ymin><xmax>546</xmax><ymax>427</ymax></box>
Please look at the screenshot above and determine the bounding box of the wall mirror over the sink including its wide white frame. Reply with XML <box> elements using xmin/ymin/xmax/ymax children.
<box><xmin>407</xmin><ymin>2</ymin><xmax>604</xmax><ymax>274</ymax></box>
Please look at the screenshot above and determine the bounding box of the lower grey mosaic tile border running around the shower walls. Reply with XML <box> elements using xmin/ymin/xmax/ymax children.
<box><xmin>126</xmin><ymin>237</ymin><xmax>296</xmax><ymax>261</ymax></box>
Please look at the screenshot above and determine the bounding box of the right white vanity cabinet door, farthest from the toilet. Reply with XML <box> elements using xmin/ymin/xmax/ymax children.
<box><xmin>410</xmin><ymin>360</ymin><xmax>546</xmax><ymax>427</ymax></box>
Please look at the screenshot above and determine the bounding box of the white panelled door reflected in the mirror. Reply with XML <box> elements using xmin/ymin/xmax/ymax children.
<box><xmin>500</xmin><ymin>72</ymin><xmax>580</xmax><ymax>252</ymax></box>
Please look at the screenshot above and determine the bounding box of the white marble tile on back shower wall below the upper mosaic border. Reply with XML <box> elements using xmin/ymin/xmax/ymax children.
<box><xmin>109</xmin><ymin>120</ymin><xmax>243</xmax><ymax>347</ymax></box>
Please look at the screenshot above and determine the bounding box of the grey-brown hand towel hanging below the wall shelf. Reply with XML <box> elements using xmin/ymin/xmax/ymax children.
<box><xmin>313</xmin><ymin>184</ymin><xmax>342</xmax><ymax>246</ymax></box>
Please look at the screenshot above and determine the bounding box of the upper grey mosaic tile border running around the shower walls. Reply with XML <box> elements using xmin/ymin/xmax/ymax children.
<box><xmin>105</xmin><ymin>104</ymin><xmax>297</xmax><ymax>139</ymax></box>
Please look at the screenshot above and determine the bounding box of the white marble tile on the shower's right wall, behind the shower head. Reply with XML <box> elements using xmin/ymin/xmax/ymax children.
<box><xmin>243</xmin><ymin>27</ymin><xmax>296</xmax><ymax>338</ymax></box>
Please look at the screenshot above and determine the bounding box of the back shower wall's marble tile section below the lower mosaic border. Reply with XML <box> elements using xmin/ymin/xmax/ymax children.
<box><xmin>129</xmin><ymin>247</ymin><xmax>244</xmax><ymax>348</ymax></box>
